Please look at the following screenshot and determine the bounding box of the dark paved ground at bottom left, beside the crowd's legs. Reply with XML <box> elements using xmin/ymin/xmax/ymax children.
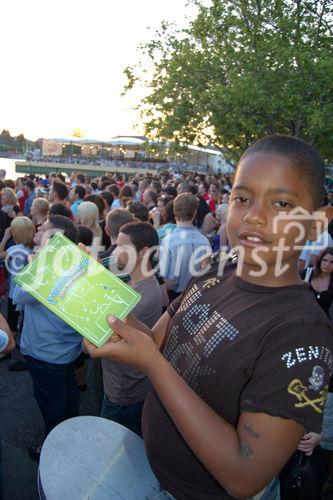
<box><xmin>0</xmin><ymin>350</ymin><xmax>98</xmax><ymax>500</ymax></box>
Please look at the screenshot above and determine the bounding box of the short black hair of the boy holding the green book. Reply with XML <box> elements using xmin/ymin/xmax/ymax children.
<box><xmin>239</xmin><ymin>135</ymin><xmax>325</xmax><ymax>208</ymax></box>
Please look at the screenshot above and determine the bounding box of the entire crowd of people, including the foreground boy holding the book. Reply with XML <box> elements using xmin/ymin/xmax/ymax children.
<box><xmin>0</xmin><ymin>136</ymin><xmax>333</xmax><ymax>500</ymax></box>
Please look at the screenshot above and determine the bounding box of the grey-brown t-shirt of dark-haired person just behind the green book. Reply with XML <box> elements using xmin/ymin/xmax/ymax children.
<box><xmin>102</xmin><ymin>276</ymin><xmax>162</xmax><ymax>406</ymax></box>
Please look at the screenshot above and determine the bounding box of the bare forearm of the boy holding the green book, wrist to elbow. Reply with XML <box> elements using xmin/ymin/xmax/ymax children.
<box><xmin>147</xmin><ymin>356</ymin><xmax>298</xmax><ymax>498</ymax></box>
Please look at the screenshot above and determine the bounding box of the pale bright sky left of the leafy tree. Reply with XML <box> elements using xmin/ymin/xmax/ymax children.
<box><xmin>0</xmin><ymin>0</ymin><xmax>195</xmax><ymax>140</ymax></box>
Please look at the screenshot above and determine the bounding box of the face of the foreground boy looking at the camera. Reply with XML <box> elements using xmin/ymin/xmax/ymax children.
<box><xmin>227</xmin><ymin>153</ymin><xmax>314</xmax><ymax>281</ymax></box>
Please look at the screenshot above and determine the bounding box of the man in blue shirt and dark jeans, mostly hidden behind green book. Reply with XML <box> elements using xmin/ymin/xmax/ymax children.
<box><xmin>13</xmin><ymin>215</ymin><xmax>82</xmax><ymax>459</ymax></box>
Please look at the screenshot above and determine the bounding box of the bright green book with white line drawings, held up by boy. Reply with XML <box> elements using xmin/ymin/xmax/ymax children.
<box><xmin>15</xmin><ymin>232</ymin><xmax>141</xmax><ymax>347</ymax></box>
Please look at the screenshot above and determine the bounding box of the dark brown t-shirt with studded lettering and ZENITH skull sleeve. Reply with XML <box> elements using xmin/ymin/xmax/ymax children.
<box><xmin>143</xmin><ymin>265</ymin><xmax>333</xmax><ymax>500</ymax></box>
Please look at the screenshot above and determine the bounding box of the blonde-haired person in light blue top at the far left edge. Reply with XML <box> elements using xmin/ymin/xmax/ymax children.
<box><xmin>0</xmin><ymin>217</ymin><xmax>36</xmax><ymax>332</ymax></box>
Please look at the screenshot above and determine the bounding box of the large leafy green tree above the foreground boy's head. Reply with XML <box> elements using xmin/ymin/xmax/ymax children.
<box><xmin>125</xmin><ymin>0</ymin><xmax>333</xmax><ymax>161</ymax></box>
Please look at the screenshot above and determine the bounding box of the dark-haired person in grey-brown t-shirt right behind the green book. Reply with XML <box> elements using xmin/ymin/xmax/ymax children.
<box><xmin>101</xmin><ymin>221</ymin><xmax>162</xmax><ymax>435</ymax></box>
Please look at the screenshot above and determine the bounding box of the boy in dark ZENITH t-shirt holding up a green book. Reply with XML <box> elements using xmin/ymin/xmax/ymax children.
<box><xmin>84</xmin><ymin>136</ymin><xmax>333</xmax><ymax>500</ymax></box>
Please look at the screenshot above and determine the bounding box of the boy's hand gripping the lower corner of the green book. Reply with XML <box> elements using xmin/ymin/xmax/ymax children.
<box><xmin>84</xmin><ymin>316</ymin><xmax>163</xmax><ymax>375</ymax></box>
